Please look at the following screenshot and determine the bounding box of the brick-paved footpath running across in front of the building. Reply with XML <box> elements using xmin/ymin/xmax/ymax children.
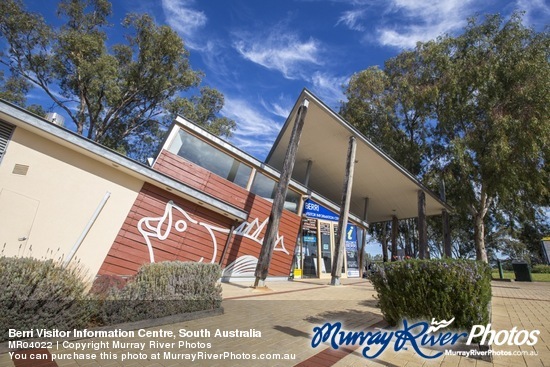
<box><xmin>0</xmin><ymin>279</ymin><xmax>550</xmax><ymax>367</ymax></box>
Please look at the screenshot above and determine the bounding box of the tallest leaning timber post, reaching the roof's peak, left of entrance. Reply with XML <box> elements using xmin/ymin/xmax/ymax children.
<box><xmin>254</xmin><ymin>99</ymin><xmax>309</xmax><ymax>287</ymax></box>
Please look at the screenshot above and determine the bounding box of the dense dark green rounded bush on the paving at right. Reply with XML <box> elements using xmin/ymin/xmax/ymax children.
<box><xmin>371</xmin><ymin>260</ymin><xmax>491</xmax><ymax>330</ymax></box>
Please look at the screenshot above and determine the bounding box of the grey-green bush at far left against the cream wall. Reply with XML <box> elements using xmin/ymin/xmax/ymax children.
<box><xmin>0</xmin><ymin>256</ymin><xmax>95</xmax><ymax>341</ymax></box>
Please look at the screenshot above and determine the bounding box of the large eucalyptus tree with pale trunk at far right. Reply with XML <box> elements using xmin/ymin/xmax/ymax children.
<box><xmin>432</xmin><ymin>13</ymin><xmax>550</xmax><ymax>261</ymax></box>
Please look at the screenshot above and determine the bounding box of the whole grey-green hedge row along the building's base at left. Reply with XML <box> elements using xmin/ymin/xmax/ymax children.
<box><xmin>0</xmin><ymin>256</ymin><xmax>222</xmax><ymax>342</ymax></box>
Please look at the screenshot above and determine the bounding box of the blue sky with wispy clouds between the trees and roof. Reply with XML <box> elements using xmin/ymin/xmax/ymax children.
<box><xmin>24</xmin><ymin>0</ymin><xmax>550</xmax><ymax>160</ymax></box>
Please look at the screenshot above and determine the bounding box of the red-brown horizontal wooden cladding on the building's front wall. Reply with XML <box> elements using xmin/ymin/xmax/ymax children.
<box><xmin>99</xmin><ymin>151</ymin><xmax>300</xmax><ymax>276</ymax></box>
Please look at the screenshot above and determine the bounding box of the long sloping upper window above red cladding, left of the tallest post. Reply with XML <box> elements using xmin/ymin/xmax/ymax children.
<box><xmin>168</xmin><ymin>130</ymin><xmax>252</xmax><ymax>188</ymax></box>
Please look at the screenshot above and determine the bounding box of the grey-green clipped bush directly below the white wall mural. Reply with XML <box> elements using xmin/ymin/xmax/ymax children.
<box><xmin>102</xmin><ymin>261</ymin><xmax>222</xmax><ymax>324</ymax></box>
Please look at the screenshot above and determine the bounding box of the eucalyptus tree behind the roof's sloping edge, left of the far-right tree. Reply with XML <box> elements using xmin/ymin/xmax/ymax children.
<box><xmin>340</xmin><ymin>52</ymin><xmax>436</xmax><ymax>256</ymax></box>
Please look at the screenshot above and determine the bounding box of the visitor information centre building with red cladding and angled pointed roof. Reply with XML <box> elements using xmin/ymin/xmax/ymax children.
<box><xmin>0</xmin><ymin>90</ymin><xmax>450</xmax><ymax>279</ymax></box>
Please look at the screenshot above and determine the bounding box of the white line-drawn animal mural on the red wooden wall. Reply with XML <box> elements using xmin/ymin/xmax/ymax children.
<box><xmin>137</xmin><ymin>200</ymin><xmax>290</xmax><ymax>268</ymax></box>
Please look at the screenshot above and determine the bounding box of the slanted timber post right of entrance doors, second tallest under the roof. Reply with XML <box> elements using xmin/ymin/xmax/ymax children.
<box><xmin>330</xmin><ymin>136</ymin><xmax>357</xmax><ymax>285</ymax></box>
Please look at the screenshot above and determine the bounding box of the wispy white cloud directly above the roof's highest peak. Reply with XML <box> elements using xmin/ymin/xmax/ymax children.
<box><xmin>233</xmin><ymin>30</ymin><xmax>322</xmax><ymax>79</ymax></box>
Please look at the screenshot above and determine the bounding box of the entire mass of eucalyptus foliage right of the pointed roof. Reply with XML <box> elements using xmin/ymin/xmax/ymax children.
<box><xmin>341</xmin><ymin>13</ymin><xmax>550</xmax><ymax>261</ymax></box>
